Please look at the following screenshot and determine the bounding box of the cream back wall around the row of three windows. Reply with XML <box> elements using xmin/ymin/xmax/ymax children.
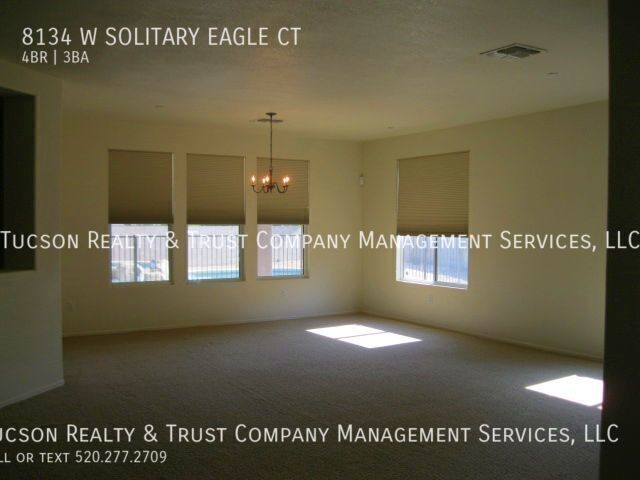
<box><xmin>62</xmin><ymin>113</ymin><xmax>362</xmax><ymax>335</ymax></box>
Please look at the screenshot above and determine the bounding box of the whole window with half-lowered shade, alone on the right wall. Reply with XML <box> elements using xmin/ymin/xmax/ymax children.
<box><xmin>396</xmin><ymin>152</ymin><xmax>469</xmax><ymax>288</ymax></box>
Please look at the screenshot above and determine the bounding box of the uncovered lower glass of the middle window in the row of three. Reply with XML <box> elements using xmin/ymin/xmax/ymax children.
<box><xmin>187</xmin><ymin>225</ymin><xmax>244</xmax><ymax>282</ymax></box>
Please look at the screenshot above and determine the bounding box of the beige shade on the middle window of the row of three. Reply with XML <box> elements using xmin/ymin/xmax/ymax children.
<box><xmin>187</xmin><ymin>153</ymin><xmax>245</xmax><ymax>225</ymax></box>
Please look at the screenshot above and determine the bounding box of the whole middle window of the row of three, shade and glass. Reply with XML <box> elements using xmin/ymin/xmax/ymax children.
<box><xmin>187</xmin><ymin>154</ymin><xmax>245</xmax><ymax>282</ymax></box>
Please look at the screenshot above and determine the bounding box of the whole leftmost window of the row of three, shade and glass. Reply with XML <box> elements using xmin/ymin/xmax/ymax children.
<box><xmin>109</xmin><ymin>150</ymin><xmax>173</xmax><ymax>283</ymax></box>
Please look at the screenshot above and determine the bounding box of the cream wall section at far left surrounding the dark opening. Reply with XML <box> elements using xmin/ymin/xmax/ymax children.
<box><xmin>0</xmin><ymin>61</ymin><xmax>63</xmax><ymax>406</ymax></box>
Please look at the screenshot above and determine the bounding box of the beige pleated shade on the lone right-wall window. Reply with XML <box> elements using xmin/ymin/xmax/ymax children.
<box><xmin>398</xmin><ymin>152</ymin><xmax>469</xmax><ymax>235</ymax></box>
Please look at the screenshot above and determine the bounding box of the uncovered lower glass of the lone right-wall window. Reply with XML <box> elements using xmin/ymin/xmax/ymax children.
<box><xmin>396</xmin><ymin>236</ymin><xmax>469</xmax><ymax>288</ymax></box>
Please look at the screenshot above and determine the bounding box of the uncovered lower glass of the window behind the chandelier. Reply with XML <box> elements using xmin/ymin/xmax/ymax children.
<box><xmin>258</xmin><ymin>225</ymin><xmax>305</xmax><ymax>277</ymax></box>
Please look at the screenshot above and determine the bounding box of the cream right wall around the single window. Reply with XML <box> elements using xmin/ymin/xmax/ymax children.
<box><xmin>363</xmin><ymin>102</ymin><xmax>608</xmax><ymax>357</ymax></box>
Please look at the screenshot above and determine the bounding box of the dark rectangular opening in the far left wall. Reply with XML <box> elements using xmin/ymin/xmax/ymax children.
<box><xmin>0</xmin><ymin>88</ymin><xmax>35</xmax><ymax>272</ymax></box>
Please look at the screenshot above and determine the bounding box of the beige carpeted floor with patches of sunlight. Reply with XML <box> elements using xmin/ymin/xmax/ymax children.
<box><xmin>0</xmin><ymin>315</ymin><xmax>600</xmax><ymax>480</ymax></box>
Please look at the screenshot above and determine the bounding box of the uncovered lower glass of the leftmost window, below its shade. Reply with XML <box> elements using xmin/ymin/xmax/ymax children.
<box><xmin>111</xmin><ymin>224</ymin><xmax>171</xmax><ymax>283</ymax></box>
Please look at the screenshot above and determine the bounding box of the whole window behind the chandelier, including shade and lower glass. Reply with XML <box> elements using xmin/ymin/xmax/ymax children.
<box><xmin>257</xmin><ymin>158</ymin><xmax>309</xmax><ymax>278</ymax></box>
